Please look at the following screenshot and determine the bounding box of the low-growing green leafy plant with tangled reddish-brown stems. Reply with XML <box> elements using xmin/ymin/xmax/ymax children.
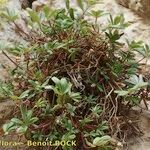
<box><xmin>0</xmin><ymin>0</ymin><xmax>149</xmax><ymax>150</ymax></box>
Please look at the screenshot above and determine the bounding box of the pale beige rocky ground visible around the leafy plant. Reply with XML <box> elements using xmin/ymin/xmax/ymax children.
<box><xmin>0</xmin><ymin>0</ymin><xmax>150</xmax><ymax>150</ymax></box>
